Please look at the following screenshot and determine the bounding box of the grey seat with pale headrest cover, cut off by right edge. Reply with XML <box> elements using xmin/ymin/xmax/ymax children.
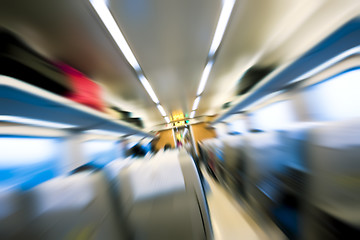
<box><xmin>307</xmin><ymin>118</ymin><xmax>360</xmax><ymax>228</ymax></box>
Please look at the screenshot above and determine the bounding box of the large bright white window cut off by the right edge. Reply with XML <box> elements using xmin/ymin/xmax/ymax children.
<box><xmin>304</xmin><ymin>68</ymin><xmax>360</xmax><ymax>121</ymax></box>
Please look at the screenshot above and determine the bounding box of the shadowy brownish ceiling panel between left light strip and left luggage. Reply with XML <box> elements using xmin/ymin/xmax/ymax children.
<box><xmin>0</xmin><ymin>0</ymin><xmax>164</xmax><ymax>126</ymax></box>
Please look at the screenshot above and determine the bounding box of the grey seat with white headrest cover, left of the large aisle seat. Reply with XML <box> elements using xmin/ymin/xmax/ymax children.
<box><xmin>20</xmin><ymin>171</ymin><xmax>126</xmax><ymax>240</ymax></box>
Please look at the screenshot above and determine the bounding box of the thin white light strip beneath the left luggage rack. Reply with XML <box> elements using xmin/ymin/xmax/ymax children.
<box><xmin>0</xmin><ymin>115</ymin><xmax>75</xmax><ymax>128</ymax></box>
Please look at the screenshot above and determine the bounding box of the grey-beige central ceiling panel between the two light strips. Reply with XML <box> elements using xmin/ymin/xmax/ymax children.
<box><xmin>110</xmin><ymin>0</ymin><xmax>221</xmax><ymax>113</ymax></box>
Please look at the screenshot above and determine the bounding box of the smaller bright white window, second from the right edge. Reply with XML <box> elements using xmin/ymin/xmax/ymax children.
<box><xmin>249</xmin><ymin>101</ymin><xmax>295</xmax><ymax>131</ymax></box>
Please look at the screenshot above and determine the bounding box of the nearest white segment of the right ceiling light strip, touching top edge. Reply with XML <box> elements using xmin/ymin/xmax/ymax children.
<box><xmin>209</xmin><ymin>0</ymin><xmax>235</xmax><ymax>56</ymax></box>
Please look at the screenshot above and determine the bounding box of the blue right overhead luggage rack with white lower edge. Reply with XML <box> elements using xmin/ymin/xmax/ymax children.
<box><xmin>212</xmin><ymin>17</ymin><xmax>360</xmax><ymax>125</ymax></box>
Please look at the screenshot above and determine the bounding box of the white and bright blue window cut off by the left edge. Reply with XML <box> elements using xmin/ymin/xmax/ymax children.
<box><xmin>0</xmin><ymin>137</ymin><xmax>61</xmax><ymax>189</ymax></box>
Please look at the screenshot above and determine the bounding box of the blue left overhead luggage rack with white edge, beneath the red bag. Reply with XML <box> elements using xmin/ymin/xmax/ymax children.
<box><xmin>0</xmin><ymin>75</ymin><xmax>152</xmax><ymax>137</ymax></box>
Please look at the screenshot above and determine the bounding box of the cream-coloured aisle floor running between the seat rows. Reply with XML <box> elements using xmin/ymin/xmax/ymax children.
<box><xmin>201</xmin><ymin>167</ymin><xmax>287</xmax><ymax>240</ymax></box>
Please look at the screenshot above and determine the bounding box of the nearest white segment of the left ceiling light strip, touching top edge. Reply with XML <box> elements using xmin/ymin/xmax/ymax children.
<box><xmin>90</xmin><ymin>0</ymin><xmax>140</xmax><ymax>71</ymax></box>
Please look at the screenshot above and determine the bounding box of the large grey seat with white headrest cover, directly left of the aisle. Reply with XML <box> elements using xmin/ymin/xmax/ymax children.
<box><xmin>107</xmin><ymin>150</ymin><xmax>212</xmax><ymax>240</ymax></box>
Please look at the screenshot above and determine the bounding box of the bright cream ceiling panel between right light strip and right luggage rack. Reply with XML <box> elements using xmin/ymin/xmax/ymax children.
<box><xmin>197</xmin><ymin>0</ymin><xmax>360</xmax><ymax>115</ymax></box>
